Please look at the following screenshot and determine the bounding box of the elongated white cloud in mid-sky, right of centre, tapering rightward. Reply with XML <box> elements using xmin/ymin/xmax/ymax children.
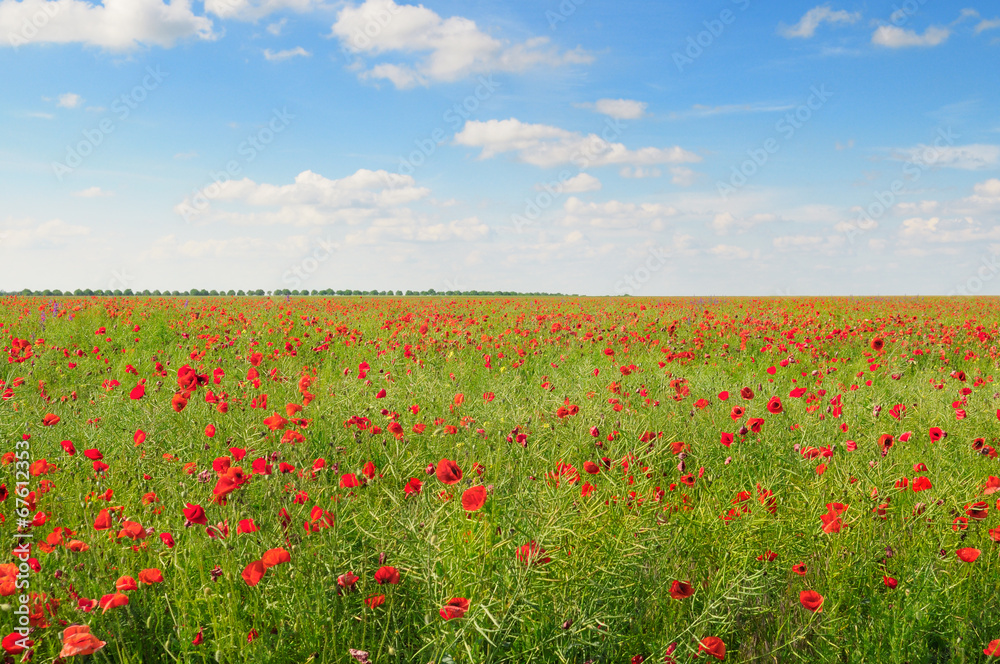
<box><xmin>455</xmin><ymin>118</ymin><xmax>701</xmax><ymax>168</ymax></box>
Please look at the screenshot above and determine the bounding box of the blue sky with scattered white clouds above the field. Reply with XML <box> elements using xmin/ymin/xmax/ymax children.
<box><xmin>0</xmin><ymin>0</ymin><xmax>1000</xmax><ymax>295</ymax></box>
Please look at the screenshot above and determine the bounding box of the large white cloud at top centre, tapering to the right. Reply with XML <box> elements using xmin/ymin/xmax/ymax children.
<box><xmin>332</xmin><ymin>0</ymin><xmax>593</xmax><ymax>88</ymax></box>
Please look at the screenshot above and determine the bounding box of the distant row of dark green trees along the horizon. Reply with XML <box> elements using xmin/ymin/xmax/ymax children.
<box><xmin>0</xmin><ymin>288</ymin><xmax>562</xmax><ymax>297</ymax></box>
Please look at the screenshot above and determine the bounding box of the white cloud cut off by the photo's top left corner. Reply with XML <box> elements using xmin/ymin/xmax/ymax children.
<box><xmin>0</xmin><ymin>0</ymin><xmax>215</xmax><ymax>51</ymax></box>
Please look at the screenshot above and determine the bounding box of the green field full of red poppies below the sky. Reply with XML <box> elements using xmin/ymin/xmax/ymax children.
<box><xmin>0</xmin><ymin>296</ymin><xmax>1000</xmax><ymax>664</ymax></box>
